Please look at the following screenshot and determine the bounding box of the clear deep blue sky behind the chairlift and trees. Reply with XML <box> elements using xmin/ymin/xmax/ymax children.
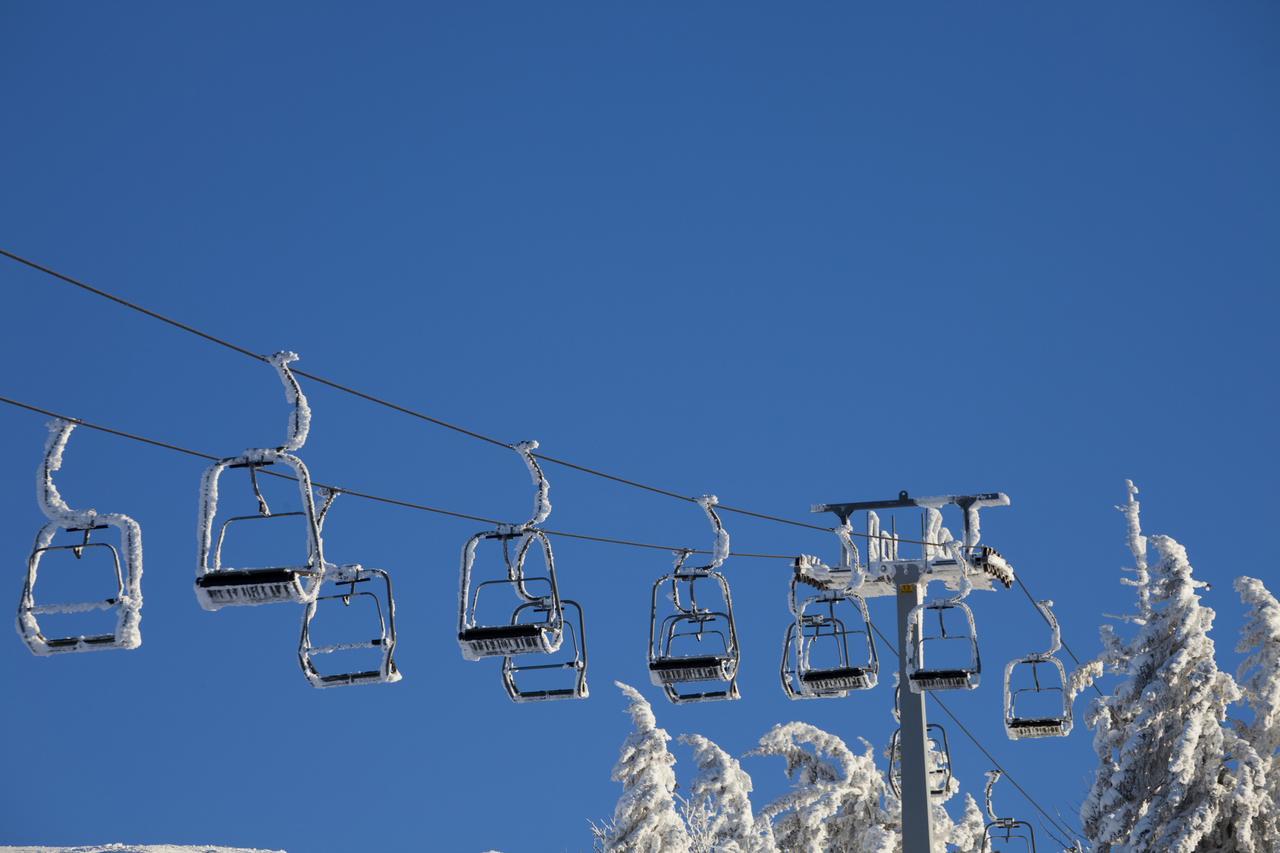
<box><xmin>0</xmin><ymin>1</ymin><xmax>1280</xmax><ymax>853</ymax></box>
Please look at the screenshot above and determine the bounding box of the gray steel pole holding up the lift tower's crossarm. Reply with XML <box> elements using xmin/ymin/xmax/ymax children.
<box><xmin>895</xmin><ymin>564</ymin><xmax>933</xmax><ymax>853</ymax></box>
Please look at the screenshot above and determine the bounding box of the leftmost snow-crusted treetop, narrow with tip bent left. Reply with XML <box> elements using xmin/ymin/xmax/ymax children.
<box><xmin>602</xmin><ymin>681</ymin><xmax>689</xmax><ymax>853</ymax></box>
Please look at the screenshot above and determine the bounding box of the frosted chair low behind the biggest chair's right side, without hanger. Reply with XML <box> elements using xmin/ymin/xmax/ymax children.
<box><xmin>298</xmin><ymin>564</ymin><xmax>401</xmax><ymax>688</ymax></box>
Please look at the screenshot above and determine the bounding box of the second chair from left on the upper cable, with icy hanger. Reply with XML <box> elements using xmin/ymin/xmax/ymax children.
<box><xmin>458</xmin><ymin>441</ymin><xmax>564</xmax><ymax>661</ymax></box>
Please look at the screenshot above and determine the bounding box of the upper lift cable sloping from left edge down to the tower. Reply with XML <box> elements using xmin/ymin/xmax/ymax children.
<box><xmin>0</xmin><ymin>248</ymin><xmax>938</xmax><ymax>545</ymax></box>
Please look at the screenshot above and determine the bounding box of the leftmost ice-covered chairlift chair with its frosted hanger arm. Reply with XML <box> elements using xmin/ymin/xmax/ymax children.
<box><xmin>17</xmin><ymin>420</ymin><xmax>142</xmax><ymax>656</ymax></box>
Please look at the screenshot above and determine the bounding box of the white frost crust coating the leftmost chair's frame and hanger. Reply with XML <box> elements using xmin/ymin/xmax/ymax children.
<box><xmin>17</xmin><ymin>419</ymin><xmax>142</xmax><ymax>656</ymax></box>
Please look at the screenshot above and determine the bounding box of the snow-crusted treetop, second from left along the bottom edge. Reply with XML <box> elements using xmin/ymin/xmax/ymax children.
<box><xmin>680</xmin><ymin>735</ymin><xmax>777</xmax><ymax>853</ymax></box>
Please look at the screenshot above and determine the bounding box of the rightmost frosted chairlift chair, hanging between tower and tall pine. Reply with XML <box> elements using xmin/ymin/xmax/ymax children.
<box><xmin>1005</xmin><ymin>599</ymin><xmax>1073</xmax><ymax>740</ymax></box>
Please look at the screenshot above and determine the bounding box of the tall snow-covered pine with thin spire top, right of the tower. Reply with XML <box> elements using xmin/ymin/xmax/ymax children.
<box><xmin>1080</xmin><ymin>483</ymin><xmax>1239</xmax><ymax>853</ymax></box>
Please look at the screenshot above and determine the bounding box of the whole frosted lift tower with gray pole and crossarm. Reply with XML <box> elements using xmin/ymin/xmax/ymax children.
<box><xmin>813</xmin><ymin>492</ymin><xmax>1014</xmax><ymax>853</ymax></box>
